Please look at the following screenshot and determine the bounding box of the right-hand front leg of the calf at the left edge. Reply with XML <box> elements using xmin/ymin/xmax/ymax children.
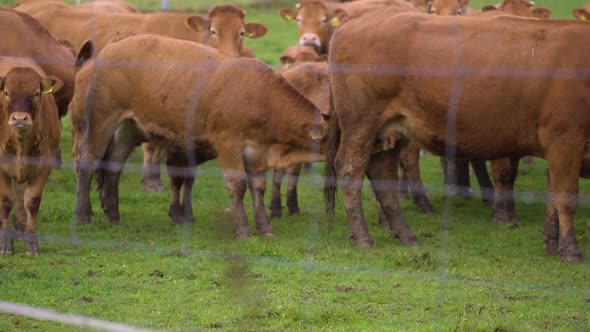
<box><xmin>17</xmin><ymin>167</ymin><xmax>51</xmax><ymax>256</ymax></box>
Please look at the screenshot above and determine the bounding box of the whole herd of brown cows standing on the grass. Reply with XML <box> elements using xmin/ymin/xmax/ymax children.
<box><xmin>0</xmin><ymin>0</ymin><xmax>590</xmax><ymax>263</ymax></box>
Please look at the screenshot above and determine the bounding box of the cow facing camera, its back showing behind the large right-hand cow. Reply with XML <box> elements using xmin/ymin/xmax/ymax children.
<box><xmin>280</xmin><ymin>0</ymin><xmax>417</xmax><ymax>54</ymax></box>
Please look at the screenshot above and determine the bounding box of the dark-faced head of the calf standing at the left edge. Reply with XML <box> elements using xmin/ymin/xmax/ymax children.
<box><xmin>0</xmin><ymin>67</ymin><xmax>63</xmax><ymax>133</ymax></box>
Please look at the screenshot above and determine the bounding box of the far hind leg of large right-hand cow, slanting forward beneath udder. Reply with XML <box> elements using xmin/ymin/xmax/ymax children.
<box><xmin>367</xmin><ymin>150</ymin><xmax>419</xmax><ymax>246</ymax></box>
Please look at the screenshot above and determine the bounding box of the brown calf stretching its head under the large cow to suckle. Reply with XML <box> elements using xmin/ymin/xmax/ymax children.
<box><xmin>71</xmin><ymin>35</ymin><xmax>326</xmax><ymax>237</ymax></box>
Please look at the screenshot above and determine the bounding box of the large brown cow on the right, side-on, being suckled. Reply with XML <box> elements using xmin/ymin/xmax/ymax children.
<box><xmin>327</xmin><ymin>11</ymin><xmax>590</xmax><ymax>263</ymax></box>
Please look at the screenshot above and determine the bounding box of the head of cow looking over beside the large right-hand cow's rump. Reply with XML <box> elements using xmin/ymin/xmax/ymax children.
<box><xmin>281</xmin><ymin>0</ymin><xmax>347</xmax><ymax>54</ymax></box>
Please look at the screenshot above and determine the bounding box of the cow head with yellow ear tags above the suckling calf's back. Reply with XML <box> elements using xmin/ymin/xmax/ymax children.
<box><xmin>186</xmin><ymin>5</ymin><xmax>267</xmax><ymax>56</ymax></box>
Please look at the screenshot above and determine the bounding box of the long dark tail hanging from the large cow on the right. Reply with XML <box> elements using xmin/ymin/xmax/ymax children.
<box><xmin>324</xmin><ymin>87</ymin><xmax>341</xmax><ymax>228</ymax></box>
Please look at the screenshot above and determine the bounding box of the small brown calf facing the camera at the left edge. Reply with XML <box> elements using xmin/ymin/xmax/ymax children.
<box><xmin>0</xmin><ymin>57</ymin><xmax>62</xmax><ymax>256</ymax></box>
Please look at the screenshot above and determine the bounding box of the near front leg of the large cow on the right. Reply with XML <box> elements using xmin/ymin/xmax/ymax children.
<box><xmin>547</xmin><ymin>149</ymin><xmax>583</xmax><ymax>264</ymax></box>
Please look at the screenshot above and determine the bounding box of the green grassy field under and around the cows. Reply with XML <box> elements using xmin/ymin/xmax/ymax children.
<box><xmin>0</xmin><ymin>0</ymin><xmax>590</xmax><ymax>331</ymax></box>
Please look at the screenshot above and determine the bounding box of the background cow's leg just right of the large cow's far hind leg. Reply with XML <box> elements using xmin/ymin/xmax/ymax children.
<box><xmin>399</xmin><ymin>142</ymin><xmax>432</xmax><ymax>213</ymax></box>
